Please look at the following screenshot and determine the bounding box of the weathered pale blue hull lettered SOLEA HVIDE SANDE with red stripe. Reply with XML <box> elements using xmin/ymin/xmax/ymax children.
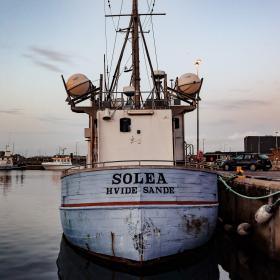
<box><xmin>60</xmin><ymin>167</ymin><xmax>218</xmax><ymax>262</ymax></box>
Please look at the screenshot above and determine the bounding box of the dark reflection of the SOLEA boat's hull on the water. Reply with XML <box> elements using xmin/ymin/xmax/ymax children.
<box><xmin>57</xmin><ymin>237</ymin><xmax>219</xmax><ymax>280</ymax></box>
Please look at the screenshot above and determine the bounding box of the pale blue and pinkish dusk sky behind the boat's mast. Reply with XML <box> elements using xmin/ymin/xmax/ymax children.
<box><xmin>0</xmin><ymin>0</ymin><xmax>280</xmax><ymax>156</ymax></box>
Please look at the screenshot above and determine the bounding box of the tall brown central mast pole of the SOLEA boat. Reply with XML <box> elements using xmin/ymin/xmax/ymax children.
<box><xmin>132</xmin><ymin>0</ymin><xmax>141</xmax><ymax>108</ymax></box>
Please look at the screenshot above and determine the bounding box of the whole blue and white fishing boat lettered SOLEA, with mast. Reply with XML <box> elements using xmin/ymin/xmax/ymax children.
<box><xmin>60</xmin><ymin>0</ymin><xmax>218</xmax><ymax>265</ymax></box>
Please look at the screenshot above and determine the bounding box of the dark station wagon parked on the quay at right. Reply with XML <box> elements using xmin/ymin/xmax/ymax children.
<box><xmin>221</xmin><ymin>154</ymin><xmax>272</xmax><ymax>171</ymax></box>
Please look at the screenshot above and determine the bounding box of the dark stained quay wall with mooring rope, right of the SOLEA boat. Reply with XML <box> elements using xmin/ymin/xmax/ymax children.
<box><xmin>218</xmin><ymin>171</ymin><xmax>280</xmax><ymax>261</ymax></box>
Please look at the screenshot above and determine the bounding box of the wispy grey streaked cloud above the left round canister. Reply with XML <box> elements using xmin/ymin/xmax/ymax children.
<box><xmin>23</xmin><ymin>46</ymin><xmax>72</xmax><ymax>73</ymax></box>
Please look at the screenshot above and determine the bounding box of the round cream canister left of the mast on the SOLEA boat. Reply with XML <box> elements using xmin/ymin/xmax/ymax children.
<box><xmin>66</xmin><ymin>74</ymin><xmax>90</xmax><ymax>96</ymax></box>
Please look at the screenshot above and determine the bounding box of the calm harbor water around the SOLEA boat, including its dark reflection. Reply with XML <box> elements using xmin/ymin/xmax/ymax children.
<box><xmin>0</xmin><ymin>170</ymin><xmax>280</xmax><ymax>280</ymax></box>
